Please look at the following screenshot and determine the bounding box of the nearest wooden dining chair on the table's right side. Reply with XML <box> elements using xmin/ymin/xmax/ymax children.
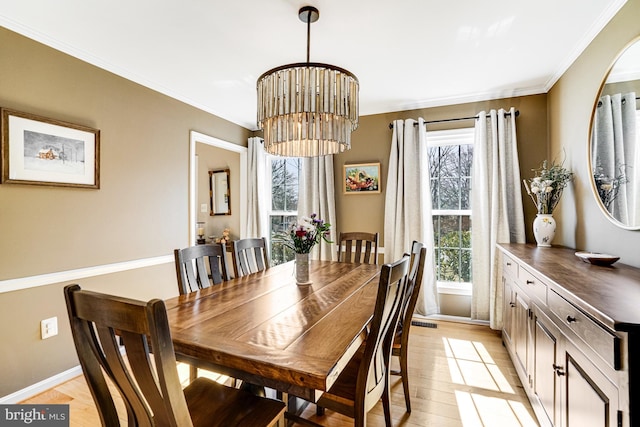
<box><xmin>317</xmin><ymin>255</ymin><xmax>410</xmax><ymax>427</ymax></box>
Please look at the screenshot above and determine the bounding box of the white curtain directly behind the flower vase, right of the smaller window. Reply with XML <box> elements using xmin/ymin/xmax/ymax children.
<box><xmin>298</xmin><ymin>155</ymin><xmax>338</xmax><ymax>261</ymax></box>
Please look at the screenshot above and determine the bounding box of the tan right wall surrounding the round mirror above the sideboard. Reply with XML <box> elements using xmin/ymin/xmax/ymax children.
<box><xmin>549</xmin><ymin>0</ymin><xmax>640</xmax><ymax>267</ymax></box>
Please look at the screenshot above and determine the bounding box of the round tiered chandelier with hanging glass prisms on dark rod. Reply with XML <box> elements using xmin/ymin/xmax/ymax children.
<box><xmin>257</xmin><ymin>6</ymin><xmax>359</xmax><ymax>157</ymax></box>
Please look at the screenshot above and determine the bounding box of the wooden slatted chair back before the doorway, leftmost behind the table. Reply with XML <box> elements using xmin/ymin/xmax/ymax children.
<box><xmin>173</xmin><ymin>243</ymin><xmax>231</xmax><ymax>295</ymax></box>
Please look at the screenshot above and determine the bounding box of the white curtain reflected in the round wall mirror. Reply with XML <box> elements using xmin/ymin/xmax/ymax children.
<box><xmin>591</xmin><ymin>92</ymin><xmax>640</xmax><ymax>225</ymax></box>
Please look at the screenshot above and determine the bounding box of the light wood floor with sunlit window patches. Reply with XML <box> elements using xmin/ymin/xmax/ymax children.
<box><xmin>23</xmin><ymin>321</ymin><xmax>538</xmax><ymax>427</ymax></box>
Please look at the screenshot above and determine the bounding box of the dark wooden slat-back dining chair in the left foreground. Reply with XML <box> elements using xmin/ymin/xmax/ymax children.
<box><xmin>64</xmin><ymin>285</ymin><xmax>285</xmax><ymax>427</ymax></box>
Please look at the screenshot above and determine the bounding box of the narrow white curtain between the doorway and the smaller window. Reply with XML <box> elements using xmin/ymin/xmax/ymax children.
<box><xmin>244</xmin><ymin>137</ymin><xmax>269</xmax><ymax>237</ymax></box>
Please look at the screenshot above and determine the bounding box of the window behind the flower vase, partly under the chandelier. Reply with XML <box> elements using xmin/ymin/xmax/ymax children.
<box><xmin>267</xmin><ymin>156</ymin><xmax>302</xmax><ymax>265</ymax></box>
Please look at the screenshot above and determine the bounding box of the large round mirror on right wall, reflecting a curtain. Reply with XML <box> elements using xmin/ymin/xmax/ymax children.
<box><xmin>589</xmin><ymin>38</ymin><xmax>640</xmax><ymax>230</ymax></box>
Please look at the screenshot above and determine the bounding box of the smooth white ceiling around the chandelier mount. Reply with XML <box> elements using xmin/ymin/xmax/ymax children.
<box><xmin>0</xmin><ymin>0</ymin><xmax>626</xmax><ymax>130</ymax></box>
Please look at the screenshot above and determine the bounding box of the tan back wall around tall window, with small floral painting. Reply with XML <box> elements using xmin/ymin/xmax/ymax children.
<box><xmin>334</xmin><ymin>95</ymin><xmax>547</xmax><ymax>246</ymax></box>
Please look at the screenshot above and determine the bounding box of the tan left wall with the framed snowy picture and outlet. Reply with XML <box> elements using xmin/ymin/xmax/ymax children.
<box><xmin>0</xmin><ymin>28</ymin><xmax>250</xmax><ymax>397</ymax></box>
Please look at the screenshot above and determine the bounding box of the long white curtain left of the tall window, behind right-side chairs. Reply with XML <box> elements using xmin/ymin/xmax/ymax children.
<box><xmin>384</xmin><ymin>119</ymin><xmax>440</xmax><ymax>315</ymax></box>
